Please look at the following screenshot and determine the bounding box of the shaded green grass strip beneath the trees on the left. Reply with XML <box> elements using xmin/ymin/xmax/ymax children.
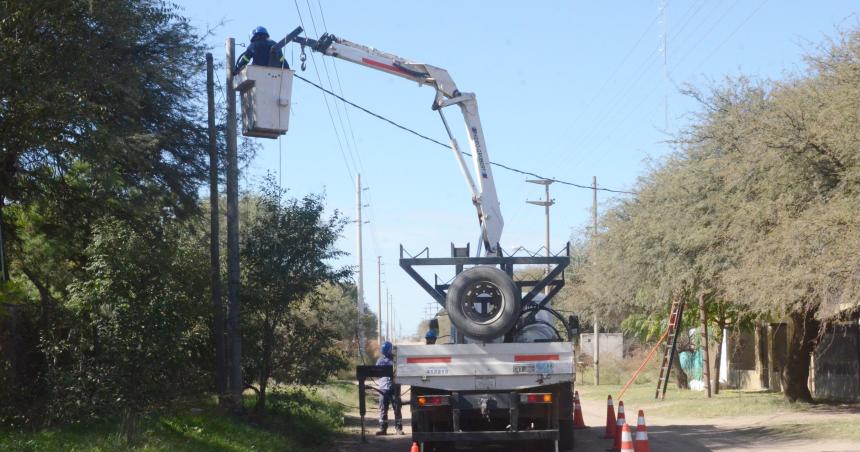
<box><xmin>0</xmin><ymin>383</ymin><xmax>345</xmax><ymax>451</ymax></box>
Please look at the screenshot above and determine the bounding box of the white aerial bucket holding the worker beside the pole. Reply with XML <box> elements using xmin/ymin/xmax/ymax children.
<box><xmin>233</xmin><ymin>65</ymin><xmax>294</xmax><ymax>138</ymax></box>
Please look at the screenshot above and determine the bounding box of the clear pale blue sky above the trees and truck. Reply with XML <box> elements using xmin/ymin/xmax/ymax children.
<box><xmin>180</xmin><ymin>0</ymin><xmax>860</xmax><ymax>340</ymax></box>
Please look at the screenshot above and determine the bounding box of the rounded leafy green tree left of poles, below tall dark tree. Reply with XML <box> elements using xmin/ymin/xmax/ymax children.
<box><xmin>58</xmin><ymin>214</ymin><xmax>211</xmax><ymax>441</ymax></box>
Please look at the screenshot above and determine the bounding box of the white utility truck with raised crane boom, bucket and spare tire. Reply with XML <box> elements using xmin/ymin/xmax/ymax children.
<box><xmin>234</xmin><ymin>27</ymin><xmax>578</xmax><ymax>451</ymax></box>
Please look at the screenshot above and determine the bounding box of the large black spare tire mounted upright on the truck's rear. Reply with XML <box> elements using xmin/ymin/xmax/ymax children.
<box><xmin>445</xmin><ymin>266</ymin><xmax>521</xmax><ymax>341</ymax></box>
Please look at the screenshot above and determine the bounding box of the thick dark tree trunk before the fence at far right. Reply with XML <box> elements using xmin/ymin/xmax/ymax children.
<box><xmin>781</xmin><ymin>310</ymin><xmax>820</xmax><ymax>402</ymax></box>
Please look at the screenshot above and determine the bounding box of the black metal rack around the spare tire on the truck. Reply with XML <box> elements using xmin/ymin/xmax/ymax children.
<box><xmin>400</xmin><ymin>242</ymin><xmax>570</xmax><ymax>340</ymax></box>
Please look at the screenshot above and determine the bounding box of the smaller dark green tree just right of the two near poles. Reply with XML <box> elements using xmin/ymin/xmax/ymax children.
<box><xmin>241</xmin><ymin>180</ymin><xmax>350</xmax><ymax>414</ymax></box>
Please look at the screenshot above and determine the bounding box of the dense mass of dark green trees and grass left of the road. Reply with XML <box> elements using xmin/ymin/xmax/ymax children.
<box><xmin>0</xmin><ymin>0</ymin><xmax>376</xmax><ymax>444</ymax></box>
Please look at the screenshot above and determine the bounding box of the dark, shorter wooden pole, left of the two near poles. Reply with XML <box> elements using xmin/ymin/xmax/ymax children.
<box><xmin>206</xmin><ymin>53</ymin><xmax>227</xmax><ymax>397</ymax></box>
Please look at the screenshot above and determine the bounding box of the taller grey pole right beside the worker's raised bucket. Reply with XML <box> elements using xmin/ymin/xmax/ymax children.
<box><xmin>224</xmin><ymin>38</ymin><xmax>244</xmax><ymax>411</ymax></box>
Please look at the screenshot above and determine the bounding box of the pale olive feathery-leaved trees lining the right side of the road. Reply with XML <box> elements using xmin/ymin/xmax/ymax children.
<box><xmin>562</xmin><ymin>28</ymin><xmax>860</xmax><ymax>402</ymax></box>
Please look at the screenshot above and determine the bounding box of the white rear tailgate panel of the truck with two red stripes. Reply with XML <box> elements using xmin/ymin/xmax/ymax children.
<box><xmin>394</xmin><ymin>342</ymin><xmax>576</xmax><ymax>391</ymax></box>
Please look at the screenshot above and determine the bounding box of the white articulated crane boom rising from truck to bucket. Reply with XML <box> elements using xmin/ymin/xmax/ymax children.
<box><xmin>280</xmin><ymin>27</ymin><xmax>504</xmax><ymax>255</ymax></box>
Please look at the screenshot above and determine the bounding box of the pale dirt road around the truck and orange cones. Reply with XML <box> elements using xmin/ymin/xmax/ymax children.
<box><xmin>333</xmin><ymin>392</ymin><xmax>860</xmax><ymax>452</ymax></box>
